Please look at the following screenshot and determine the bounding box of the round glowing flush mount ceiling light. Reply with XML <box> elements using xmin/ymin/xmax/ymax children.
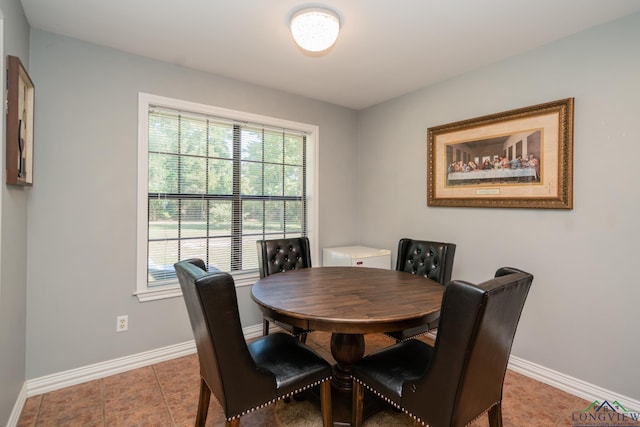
<box><xmin>291</xmin><ymin>7</ymin><xmax>340</xmax><ymax>53</ymax></box>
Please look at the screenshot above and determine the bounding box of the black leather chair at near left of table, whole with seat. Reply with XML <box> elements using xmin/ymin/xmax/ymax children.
<box><xmin>175</xmin><ymin>259</ymin><xmax>333</xmax><ymax>427</ymax></box>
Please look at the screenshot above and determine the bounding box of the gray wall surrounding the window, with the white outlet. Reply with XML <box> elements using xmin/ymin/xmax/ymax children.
<box><xmin>26</xmin><ymin>30</ymin><xmax>358</xmax><ymax>378</ymax></box>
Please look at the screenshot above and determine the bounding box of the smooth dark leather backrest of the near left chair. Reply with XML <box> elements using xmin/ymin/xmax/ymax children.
<box><xmin>175</xmin><ymin>259</ymin><xmax>276</xmax><ymax>415</ymax></box>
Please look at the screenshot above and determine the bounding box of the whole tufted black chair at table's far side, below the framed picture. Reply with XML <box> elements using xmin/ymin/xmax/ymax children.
<box><xmin>386</xmin><ymin>239</ymin><xmax>456</xmax><ymax>342</ymax></box>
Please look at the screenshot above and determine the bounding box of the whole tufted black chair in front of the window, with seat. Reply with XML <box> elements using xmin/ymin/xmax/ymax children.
<box><xmin>256</xmin><ymin>237</ymin><xmax>311</xmax><ymax>342</ymax></box>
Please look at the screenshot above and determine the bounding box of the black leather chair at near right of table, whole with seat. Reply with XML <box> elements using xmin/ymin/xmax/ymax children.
<box><xmin>351</xmin><ymin>267</ymin><xmax>533</xmax><ymax>427</ymax></box>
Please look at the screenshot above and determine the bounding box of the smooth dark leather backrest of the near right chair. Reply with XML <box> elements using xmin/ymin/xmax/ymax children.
<box><xmin>403</xmin><ymin>267</ymin><xmax>533</xmax><ymax>426</ymax></box>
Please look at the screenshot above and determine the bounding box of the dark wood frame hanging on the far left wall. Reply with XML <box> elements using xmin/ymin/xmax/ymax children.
<box><xmin>7</xmin><ymin>55</ymin><xmax>35</xmax><ymax>186</ymax></box>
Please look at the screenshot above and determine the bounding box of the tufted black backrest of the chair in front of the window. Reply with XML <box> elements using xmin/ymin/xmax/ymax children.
<box><xmin>256</xmin><ymin>237</ymin><xmax>311</xmax><ymax>278</ymax></box>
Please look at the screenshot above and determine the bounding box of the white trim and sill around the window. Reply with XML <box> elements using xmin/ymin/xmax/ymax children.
<box><xmin>134</xmin><ymin>92</ymin><xmax>320</xmax><ymax>302</ymax></box>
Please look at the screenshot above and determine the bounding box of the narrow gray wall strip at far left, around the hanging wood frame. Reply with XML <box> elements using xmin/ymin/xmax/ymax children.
<box><xmin>0</xmin><ymin>0</ymin><xmax>29</xmax><ymax>425</ymax></box>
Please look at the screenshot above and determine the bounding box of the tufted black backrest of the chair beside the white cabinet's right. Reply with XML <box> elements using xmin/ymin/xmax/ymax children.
<box><xmin>396</xmin><ymin>239</ymin><xmax>456</xmax><ymax>285</ymax></box>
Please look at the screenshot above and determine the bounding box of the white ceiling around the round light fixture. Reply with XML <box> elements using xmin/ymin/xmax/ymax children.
<box><xmin>22</xmin><ymin>0</ymin><xmax>640</xmax><ymax>109</ymax></box>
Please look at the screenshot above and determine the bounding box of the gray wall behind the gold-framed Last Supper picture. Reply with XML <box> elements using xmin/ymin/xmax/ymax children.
<box><xmin>359</xmin><ymin>14</ymin><xmax>640</xmax><ymax>399</ymax></box>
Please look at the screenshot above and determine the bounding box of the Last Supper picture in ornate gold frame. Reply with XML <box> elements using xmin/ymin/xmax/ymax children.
<box><xmin>427</xmin><ymin>98</ymin><xmax>574</xmax><ymax>209</ymax></box>
